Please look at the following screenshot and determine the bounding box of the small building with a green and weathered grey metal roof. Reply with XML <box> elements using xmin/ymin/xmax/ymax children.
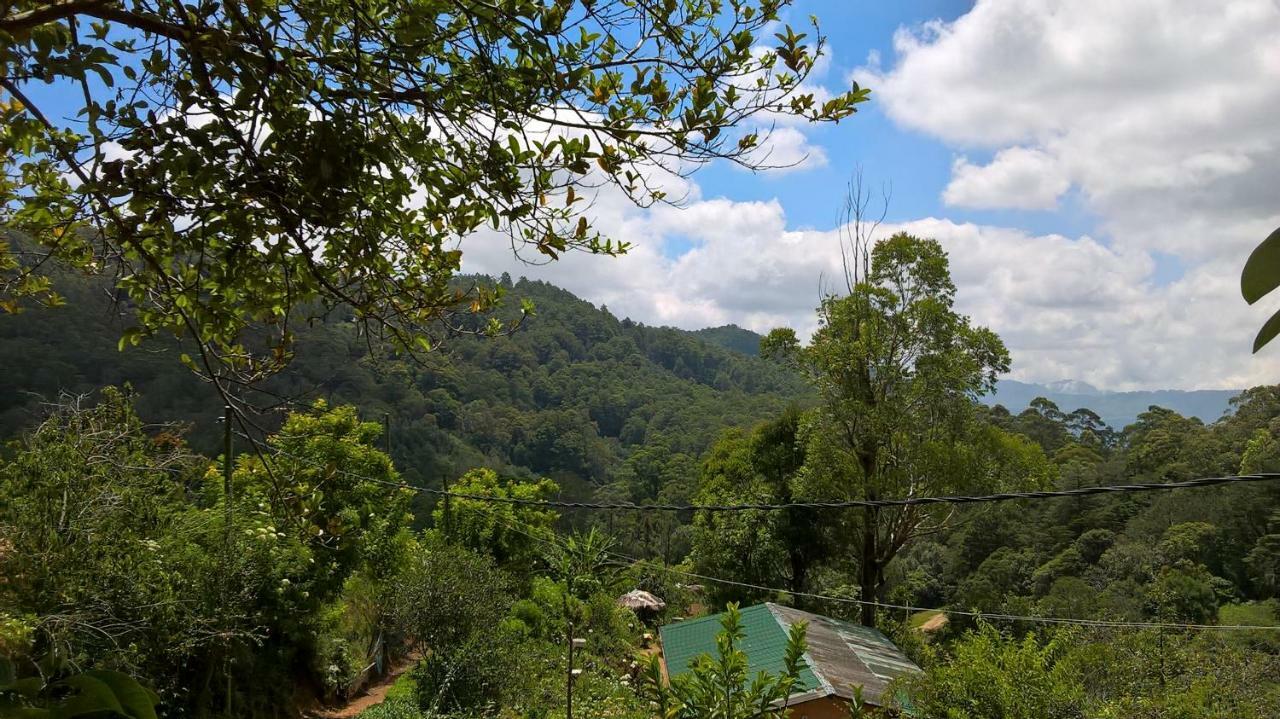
<box><xmin>660</xmin><ymin>603</ymin><xmax>920</xmax><ymax>719</ymax></box>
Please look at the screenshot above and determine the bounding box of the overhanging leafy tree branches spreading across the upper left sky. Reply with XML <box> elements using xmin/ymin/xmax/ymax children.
<box><xmin>0</xmin><ymin>0</ymin><xmax>868</xmax><ymax>393</ymax></box>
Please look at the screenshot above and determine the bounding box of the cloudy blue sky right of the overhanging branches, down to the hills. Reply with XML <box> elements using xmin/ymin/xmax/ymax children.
<box><xmin>463</xmin><ymin>0</ymin><xmax>1280</xmax><ymax>390</ymax></box>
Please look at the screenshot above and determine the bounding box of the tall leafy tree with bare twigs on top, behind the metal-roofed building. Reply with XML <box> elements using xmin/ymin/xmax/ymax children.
<box><xmin>762</xmin><ymin>233</ymin><xmax>1046</xmax><ymax>624</ymax></box>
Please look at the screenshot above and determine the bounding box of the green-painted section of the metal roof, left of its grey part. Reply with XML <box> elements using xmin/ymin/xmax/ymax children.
<box><xmin>659</xmin><ymin>604</ymin><xmax>823</xmax><ymax>693</ymax></box>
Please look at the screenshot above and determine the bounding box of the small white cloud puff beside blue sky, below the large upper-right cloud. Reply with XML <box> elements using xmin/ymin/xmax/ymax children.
<box><xmin>942</xmin><ymin>147</ymin><xmax>1071</xmax><ymax>210</ymax></box>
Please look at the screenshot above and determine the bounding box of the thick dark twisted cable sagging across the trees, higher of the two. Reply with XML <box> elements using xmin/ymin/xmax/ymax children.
<box><xmin>247</xmin><ymin>437</ymin><xmax>1280</xmax><ymax>512</ymax></box>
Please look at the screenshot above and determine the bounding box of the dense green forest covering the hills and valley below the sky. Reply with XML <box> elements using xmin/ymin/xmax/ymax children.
<box><xmin>0</xmin><ymin>230</ymin><xmax>1280</xmax><ymax>718</ymax></box>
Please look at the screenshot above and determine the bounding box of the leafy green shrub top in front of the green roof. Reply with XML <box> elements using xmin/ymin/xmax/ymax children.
<box><xmin>644</xmin><ymin>604</ymin><xmax>806</xmax><ymax>719</ymax></box>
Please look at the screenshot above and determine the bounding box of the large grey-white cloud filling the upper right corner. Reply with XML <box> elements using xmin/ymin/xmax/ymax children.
<box><xmin>854</xmin><ymin>0</ymin><xmax>1280</xmax><ymax>252</ymax></box>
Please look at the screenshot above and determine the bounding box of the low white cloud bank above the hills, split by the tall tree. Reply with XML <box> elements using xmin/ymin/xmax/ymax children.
<box><xmin>465</xmin><ymin>175</ymin><xmax>1275</xmax><ymax>389</ymax></box>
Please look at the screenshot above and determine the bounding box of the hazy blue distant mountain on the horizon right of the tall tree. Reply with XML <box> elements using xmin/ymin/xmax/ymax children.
<box><xmin>983</xmin><ymin>380</ymin><xmax>1242</xmax><ymax>430</ymax></box>
